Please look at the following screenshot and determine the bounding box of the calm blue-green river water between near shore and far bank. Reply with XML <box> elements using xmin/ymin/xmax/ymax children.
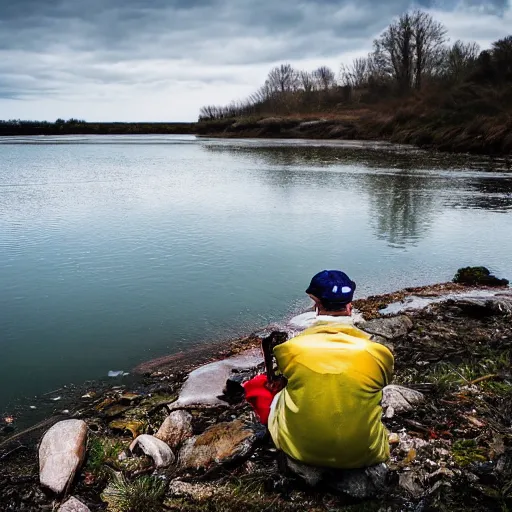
<box><xmin>0</xmin><ymin>136</ymin><xmax>512</xmax><ymax>412</ymax></box>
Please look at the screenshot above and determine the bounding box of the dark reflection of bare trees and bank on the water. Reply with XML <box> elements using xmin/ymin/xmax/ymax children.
<box><xmin>204</xmin><ymin>140</ymin><xmax>512</xmax><ymax>248</ymax></box>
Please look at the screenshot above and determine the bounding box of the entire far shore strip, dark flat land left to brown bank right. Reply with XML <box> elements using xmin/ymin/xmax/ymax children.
<box><xmin>0</xmin><ymin>118</ymin><xmax>512</xmax><ymax>159</ymax></box>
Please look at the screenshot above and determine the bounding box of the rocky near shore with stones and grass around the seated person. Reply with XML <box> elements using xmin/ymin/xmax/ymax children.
<box><xmin>0</xmin><ymin>269</ymin><xmax>512</xmax><ymax>512</ymax></box>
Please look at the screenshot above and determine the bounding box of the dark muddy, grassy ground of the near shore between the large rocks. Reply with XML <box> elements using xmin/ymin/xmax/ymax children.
<box><xmin>0</xmin><ymin>283</ymin><xmax>512</xmax><ymax>512</ymax></box>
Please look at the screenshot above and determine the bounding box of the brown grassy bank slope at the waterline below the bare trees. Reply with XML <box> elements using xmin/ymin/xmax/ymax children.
<box><xmin>196</xmin><ymin>108</ymin><xmax>512</xmax><ymax>157</ymax></box>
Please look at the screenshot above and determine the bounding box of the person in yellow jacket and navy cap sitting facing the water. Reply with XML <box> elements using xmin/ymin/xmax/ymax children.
<box><xmin>244</xmin><ymin>270</ymin><xmax>394</xmax><ymax>469</ymax></box>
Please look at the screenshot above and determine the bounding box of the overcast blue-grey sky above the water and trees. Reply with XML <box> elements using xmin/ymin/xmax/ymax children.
<box><xmin>0</xmin><ymin>0</ymin><xmax>512</xmax><ymax>121</ymax></box>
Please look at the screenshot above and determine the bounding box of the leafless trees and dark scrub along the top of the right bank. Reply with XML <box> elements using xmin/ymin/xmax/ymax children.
<box><xmin>199</xmin><ymin>10</ymin><xmax>512</xmax><ymax>121</ymax></box>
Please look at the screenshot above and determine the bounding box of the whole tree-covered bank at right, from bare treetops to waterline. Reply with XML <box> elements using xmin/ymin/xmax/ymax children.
<box><xmin>198</xmin><ymin>10</ymin><xmax>512</xmax><ymax>154</ymax></box>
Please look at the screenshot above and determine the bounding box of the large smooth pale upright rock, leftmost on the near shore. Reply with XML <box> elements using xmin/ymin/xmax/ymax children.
<box><xmin>39</xmin><ymin>420</ymin><xmax>87</xmax><ymax>494</ymax></box>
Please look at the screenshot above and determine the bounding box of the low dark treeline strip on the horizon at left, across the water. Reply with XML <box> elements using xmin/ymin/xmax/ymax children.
<box><xmin>0</xmin><ymin>119</ymin><xmax>195</xmax><ymax>136</ymax></box>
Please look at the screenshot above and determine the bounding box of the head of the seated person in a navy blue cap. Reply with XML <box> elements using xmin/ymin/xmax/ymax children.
<box><xmin>306</xmin><ymin>270</ymin><xmax>356</xmax><ymax>314</ymax></box>
